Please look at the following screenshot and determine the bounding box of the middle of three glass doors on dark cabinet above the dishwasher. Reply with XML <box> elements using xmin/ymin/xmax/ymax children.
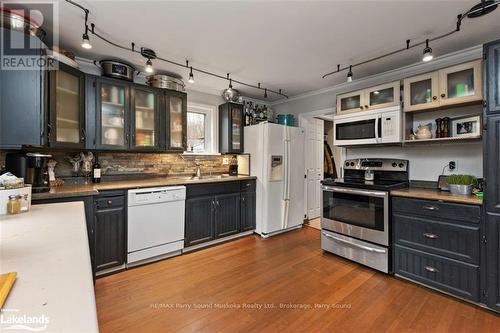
<box><xmin>130</xmin><ymin>87</ymin><xmax>160</xmax><ymax>151</ymax></box>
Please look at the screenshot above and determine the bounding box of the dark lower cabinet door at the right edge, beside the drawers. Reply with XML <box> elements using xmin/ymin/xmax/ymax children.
<box><xmin>486</xmin><ymin>213</ymin><xmax>500</xmax><ymax>311</ymax></box>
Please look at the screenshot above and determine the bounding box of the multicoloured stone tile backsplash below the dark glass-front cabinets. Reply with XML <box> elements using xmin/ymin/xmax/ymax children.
<box><xmin>0</xmin><ymin>151</ymin><xmax>231</xmax><ymax>178</ymax></box>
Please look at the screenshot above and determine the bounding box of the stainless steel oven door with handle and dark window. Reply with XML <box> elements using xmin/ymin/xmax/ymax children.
<box><xmin>321</xmin><ymin>186</ymin><xmax>389</xmax><ymax>246</ymax></box>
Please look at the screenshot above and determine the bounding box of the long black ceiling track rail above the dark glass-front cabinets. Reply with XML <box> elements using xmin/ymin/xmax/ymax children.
<box><xmin>65</xmin><ymin>0</ymin><xmax>288</xmax><ymax>98</ymax></box>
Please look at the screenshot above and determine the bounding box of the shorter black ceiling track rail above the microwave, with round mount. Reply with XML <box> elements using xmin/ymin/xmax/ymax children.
<box><xmin>321</xmin><ymin>0</ymin><xmax>500</xmax><ymax>79</ymax></box>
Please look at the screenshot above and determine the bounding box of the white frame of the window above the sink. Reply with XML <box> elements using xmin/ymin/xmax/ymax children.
<box><xmin>184</xmin><ymin>102</ymin><xmax>220</xmax><ymax>155</ymax></box>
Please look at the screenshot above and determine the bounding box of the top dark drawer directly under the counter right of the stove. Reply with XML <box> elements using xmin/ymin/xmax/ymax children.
<box><xmin>392</xmin><ymin>197</ymin><xmax>481</xmax><ymax>223</ymax></box>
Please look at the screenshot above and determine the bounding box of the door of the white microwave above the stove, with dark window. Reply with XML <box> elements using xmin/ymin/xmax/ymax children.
<box><xmin>333</xmin><ymin>114</ymin><xmax>382</xmax><ymax>146</ymax></box>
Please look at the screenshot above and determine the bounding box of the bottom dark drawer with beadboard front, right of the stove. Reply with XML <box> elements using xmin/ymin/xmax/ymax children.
<box><xmin>394</xmin><ymin>245</ymin><xmax>479</xmax><ymax>301</ymax></box>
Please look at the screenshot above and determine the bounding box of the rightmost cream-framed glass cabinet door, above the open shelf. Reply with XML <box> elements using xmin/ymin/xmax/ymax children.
<box><xmin>439</xmin><ymin>60</ymin><xmax>483</xmax><ymax>105</ymax></box>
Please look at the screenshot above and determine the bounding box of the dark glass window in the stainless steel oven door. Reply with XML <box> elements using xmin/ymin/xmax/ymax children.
<box><xmin>323</xmin><ymin>191</ymin><xmax>384</xmax><ymax>231</ymax></box>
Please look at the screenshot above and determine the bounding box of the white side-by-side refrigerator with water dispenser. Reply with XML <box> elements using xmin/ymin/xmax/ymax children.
<box><xmin>244</xmin><ymin>123</ymin><xmax>304</xmax><ymax>237</ymax></box>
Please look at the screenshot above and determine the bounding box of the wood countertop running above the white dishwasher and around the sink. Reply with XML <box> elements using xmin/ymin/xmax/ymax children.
<box><xmin>32</xmin><ymin>175</ymin><xmax>257</xmax><ymax>200</ymax></box>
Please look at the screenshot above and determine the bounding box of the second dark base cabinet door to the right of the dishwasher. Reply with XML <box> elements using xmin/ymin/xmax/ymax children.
<box><xmin>215</xmin><ymin>193</ymin><xmax>240</xmax><ymax>238</ymax></box>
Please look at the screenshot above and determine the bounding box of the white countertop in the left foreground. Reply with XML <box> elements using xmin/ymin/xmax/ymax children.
<box><xmin>0</xmin><ymin>202</ymin><xmax>99</xmax><ymax>332</ymax></box>
